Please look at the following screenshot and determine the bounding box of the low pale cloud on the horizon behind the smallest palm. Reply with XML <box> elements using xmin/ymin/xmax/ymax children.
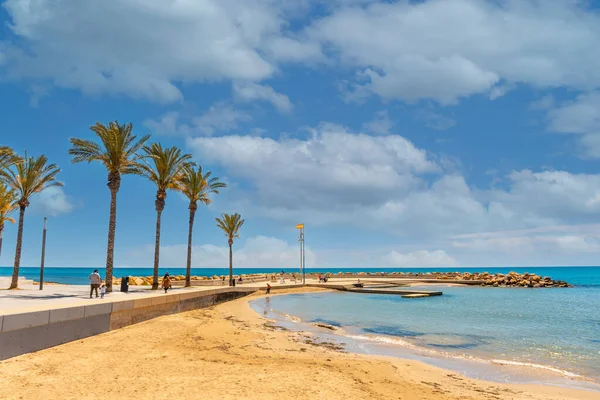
<box><xmin>123</xmin><ymin>236</ymin><xmax>316</xmax><ymax>269</ymax></box>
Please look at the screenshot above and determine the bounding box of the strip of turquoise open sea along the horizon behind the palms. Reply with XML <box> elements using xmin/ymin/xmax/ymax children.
<box><xmin>0</xmin><ymin>267</ymin><xmax>600</xmax><ymax>286</ymax></box>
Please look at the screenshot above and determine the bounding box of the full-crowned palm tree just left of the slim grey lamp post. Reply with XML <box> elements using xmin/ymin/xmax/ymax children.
<box><xmin>4</xmin><ymin>153</ymin><xmax>63</xmax><ymax>289</ymax></box>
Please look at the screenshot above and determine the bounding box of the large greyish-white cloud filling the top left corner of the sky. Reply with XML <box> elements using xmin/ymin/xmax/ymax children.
<box><xmin>3</xmin><ymin>0</ymin><xmax>296</xmax><ymax>102</ymax></box>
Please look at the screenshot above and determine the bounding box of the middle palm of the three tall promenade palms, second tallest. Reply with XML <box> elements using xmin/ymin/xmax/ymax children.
<box><xmin>140</xmin><ymin>143</ymin><xmax>192</xmax><ymax>290</ymax></box>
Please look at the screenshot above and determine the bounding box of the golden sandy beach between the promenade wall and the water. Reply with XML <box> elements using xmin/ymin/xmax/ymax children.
<box><xmin>0</xmin><ymin>289</ymin><xmax>600</xmax><ymax>400</ymax></box>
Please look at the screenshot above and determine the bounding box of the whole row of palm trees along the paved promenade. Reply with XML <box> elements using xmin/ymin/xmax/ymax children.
<box><xmin>0</xmin><ymin>121</ymin><xmax>244</xmax><ymax>292</ymax></box>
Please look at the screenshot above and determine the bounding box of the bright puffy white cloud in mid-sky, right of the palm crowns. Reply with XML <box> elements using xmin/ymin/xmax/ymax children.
<box><xmin>187</xmin><ymin>124</ymin><xmax>437</xmax><ymax>212</ymax></box>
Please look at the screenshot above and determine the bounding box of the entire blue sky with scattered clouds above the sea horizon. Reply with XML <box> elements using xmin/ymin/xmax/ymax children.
<box><xmin>0</xmin><ymin>0</ymin><xmax>600</xmax><ymax>269</ymax></box>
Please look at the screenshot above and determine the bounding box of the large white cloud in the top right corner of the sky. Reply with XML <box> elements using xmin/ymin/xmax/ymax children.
<box><xmin>307</xmin><ymin>0</ymin><xmax>600</xmax><ymax>104</ymax></box>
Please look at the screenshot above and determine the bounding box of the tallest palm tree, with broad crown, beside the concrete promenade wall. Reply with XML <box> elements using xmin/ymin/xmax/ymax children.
<box><xmin>69</xmin><ymin>121</ymin><xmax>150</xmax><ymax>293</ymax></box>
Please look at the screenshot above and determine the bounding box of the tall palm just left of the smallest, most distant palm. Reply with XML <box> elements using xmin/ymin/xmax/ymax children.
<box><xmin>178</xmin><ymin>165</ymin><xmax>227</xmax><ymax>287</ymax></box>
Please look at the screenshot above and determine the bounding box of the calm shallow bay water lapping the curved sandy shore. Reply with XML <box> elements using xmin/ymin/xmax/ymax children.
<box><xmin>252</xmin><ymin>267</ymin><xmax>600</xmax><ymax>390</ymax></box>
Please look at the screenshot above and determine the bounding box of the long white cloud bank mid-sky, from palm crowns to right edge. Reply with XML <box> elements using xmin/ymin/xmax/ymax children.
<box><xmin>187</xmin><ymin>124</ymin><xmax>600</xmax><ymax>241</ymax></box>
